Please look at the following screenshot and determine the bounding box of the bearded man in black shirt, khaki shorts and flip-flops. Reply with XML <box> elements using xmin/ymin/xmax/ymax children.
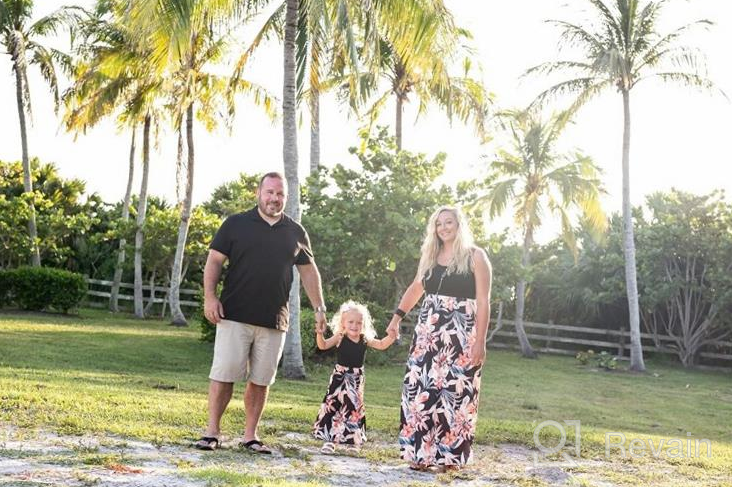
<box><xmin>196</xmin><ymin>172</ymin><xmax>326</xmax><ymax>453</ymax></box>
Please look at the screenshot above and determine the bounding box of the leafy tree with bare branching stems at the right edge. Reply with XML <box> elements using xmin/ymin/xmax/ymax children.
<box><xmin>638</xmin><ymin>190</ymin><xmax>732</xmax><ymax>367</ymax></box>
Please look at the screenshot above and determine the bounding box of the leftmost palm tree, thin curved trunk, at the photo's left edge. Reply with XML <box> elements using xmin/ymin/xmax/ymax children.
<box><xmin>0</xmin><ymin>0</ymin><xmax>68</xmax><ymax>266</ymax></box>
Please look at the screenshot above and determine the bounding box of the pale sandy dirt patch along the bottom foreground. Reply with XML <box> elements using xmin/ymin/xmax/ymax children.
<box><xmin>0</xmin><ymin>426</ymin><xmax>716</xmax><ymax>487</ymax></box>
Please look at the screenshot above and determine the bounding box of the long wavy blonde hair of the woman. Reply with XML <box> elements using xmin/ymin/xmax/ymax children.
<box><xmin>417</xmin><ymin>206</ymin><xmax>475</xmax><ymax>279</ymax></box>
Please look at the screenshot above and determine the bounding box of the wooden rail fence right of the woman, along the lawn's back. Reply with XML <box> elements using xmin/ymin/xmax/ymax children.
<box><xmin>401</xmin><ymin>319</ymin><xmax>732</xmax><ymax>368</ymax></box>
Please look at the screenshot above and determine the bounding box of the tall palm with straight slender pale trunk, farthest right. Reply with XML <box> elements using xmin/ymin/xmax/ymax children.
<box><xmin>527</xmin><ymin>0</ymin><xmax>713</xmax><ymax>372</ymax></box>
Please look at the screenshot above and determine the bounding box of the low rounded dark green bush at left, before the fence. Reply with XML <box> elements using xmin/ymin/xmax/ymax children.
<box><xmin>0</xmin><ymin>267</ymin><xmax>87</xmax><ymax>313</ymax></box>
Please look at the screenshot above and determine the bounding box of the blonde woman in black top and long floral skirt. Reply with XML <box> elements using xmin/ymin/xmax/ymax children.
<box><xmin>389</xmin><ymin>207</ymin><xmax>491</xmax><ymax>471</ymax></box>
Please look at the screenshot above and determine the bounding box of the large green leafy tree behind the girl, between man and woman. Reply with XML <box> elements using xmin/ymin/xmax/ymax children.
<box><xmin>303</xmin><ymin>129</ymin><xmax>456</xmax><ymax>322</ymax></box>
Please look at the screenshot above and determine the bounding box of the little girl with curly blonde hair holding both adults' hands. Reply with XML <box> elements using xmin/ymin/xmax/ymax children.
<box><xmin>313</xmin><ymin>301</ymin><xmax>396</xmax><ymax>453</ymax></box>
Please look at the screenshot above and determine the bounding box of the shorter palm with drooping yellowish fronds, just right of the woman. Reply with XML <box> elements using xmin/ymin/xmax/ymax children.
<box><xmin>478</xmin><ymin>110</ymin><xmax>606</xmax><ymax>358</ymax></box>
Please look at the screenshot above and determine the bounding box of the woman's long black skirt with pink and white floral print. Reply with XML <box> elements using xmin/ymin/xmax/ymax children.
<box><xmin>399</xmin><ymin>294</ymin><xmax>481</xmax><ymax>466</ymax></box>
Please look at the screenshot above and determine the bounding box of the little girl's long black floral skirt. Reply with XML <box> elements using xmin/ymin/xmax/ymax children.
<box><xmin>313</xmin><ymin>364</ymin><xmax>366</xmax><ymax>445</ymax></box>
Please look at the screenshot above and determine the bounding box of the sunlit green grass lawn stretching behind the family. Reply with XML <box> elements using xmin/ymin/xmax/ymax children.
<box><xmin>0</xmin><ymin>310</ymin><xmax>732</xmax><ymax>486</ymax></box>
